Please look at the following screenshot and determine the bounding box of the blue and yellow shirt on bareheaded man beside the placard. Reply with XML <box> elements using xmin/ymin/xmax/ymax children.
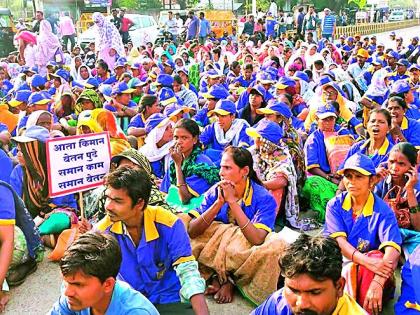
<box><xmin>96</xmin><ymin>206</ymin><xmax>195</xmax><ymax>304</ymax></box>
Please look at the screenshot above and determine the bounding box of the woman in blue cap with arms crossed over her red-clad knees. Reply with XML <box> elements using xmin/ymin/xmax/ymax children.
<box><xmin>324</xmin><ymin>153</ymin><xmax>401</xmax><ymax>314</ymax></box>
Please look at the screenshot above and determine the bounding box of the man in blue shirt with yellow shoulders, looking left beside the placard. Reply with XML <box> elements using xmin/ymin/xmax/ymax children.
<box><xmin>95</xmin><ymin>167</ymin><xmax>208</xmax><ymax>315</ymax></box>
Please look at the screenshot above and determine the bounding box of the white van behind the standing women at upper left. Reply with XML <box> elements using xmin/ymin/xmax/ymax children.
<box><xmin>78</xmin><ymin>14</ymin><xmax>159</xmax><ymax>48</ymax></box>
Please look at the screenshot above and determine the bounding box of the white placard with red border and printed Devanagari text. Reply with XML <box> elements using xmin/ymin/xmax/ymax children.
<box><xmin>47</xmin><ymin>132</ymin><xmax>111</xmax><ymax>197</ymax></box>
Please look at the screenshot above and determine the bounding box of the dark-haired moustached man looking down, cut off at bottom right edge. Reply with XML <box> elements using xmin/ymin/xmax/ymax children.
<box><xmin>251</xmin><ymin>234</ymin><xmax>366</xmax><ymax>315</ymax></box>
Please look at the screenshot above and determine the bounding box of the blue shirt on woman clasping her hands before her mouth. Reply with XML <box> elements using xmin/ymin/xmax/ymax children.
<box><xmin>188</xmin><ymin>179</ymin><xmax>277</xmax><ymax>232</ymax></box>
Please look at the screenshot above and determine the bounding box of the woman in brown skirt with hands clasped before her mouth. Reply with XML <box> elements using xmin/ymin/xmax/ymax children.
<box><xmin>188</xmin><ymin>146</ymin><xmax>284</xmax><ymax>304</ymax></box>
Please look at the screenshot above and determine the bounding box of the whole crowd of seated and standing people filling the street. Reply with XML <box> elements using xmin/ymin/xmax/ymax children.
<box><xmin>0</xmin><ymin>5</ymin><xmax>420</xmax><ymax>315</ymax></box>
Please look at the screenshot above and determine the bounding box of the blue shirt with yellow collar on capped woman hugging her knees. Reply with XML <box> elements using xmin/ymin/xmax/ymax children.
<box><xmin>324</xmin><ymin>192</ymin><xmax>402</xmax><ymax>253</ymax></box>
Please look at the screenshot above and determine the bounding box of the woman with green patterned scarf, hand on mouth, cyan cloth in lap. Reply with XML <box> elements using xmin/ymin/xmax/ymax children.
<box><xmin>161</xmin><ymin>118</ymin><xmax>219</xmax><ymax>211</ymax></box>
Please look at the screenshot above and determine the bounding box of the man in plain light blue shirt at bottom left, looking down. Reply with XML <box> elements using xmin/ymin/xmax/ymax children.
<box><xmin>49</xmin><ymin>232</ymin><xmax>159</xmax><ymax>315</ymax></box>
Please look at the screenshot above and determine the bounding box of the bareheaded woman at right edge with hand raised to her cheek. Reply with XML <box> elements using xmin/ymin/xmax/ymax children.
<box><xmin>375</xmin><ymin>142</ymin><xmax>420</xmax><ymax>254</ymax></box>
